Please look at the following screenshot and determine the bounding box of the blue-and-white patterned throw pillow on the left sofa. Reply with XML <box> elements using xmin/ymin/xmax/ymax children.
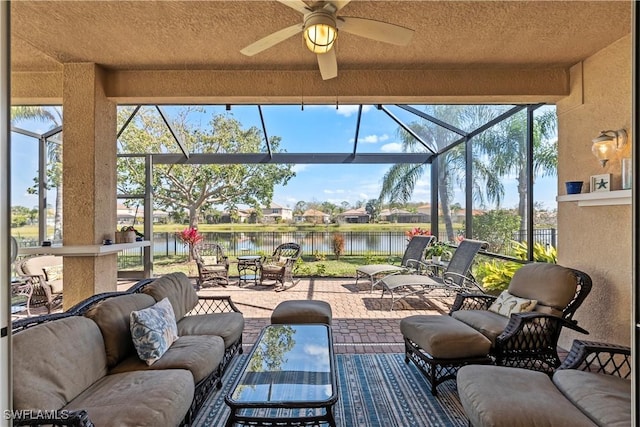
<box><xmin>129</xmin><ymin>298</ymin><xmax>178</xmax><ymax>366</ymax></box>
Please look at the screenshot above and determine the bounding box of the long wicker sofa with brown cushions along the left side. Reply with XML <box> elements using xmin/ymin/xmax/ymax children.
<box><xmin>12</xmin><ymin>273</ymin><xmax>244</xmax><ymax>426</ymax></box>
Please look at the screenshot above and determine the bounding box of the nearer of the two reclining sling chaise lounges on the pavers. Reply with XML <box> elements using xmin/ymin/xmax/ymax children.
<box><xmin>376</xmin><ymin>237</ymin><xmax>489</xmax><ymax>310</ymax></box>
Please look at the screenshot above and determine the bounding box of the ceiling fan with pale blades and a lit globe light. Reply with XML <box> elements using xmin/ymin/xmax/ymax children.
<box><xmin>240</xmin><ymin>0</ymin><xmax>414</xmax><ymax>80</ymax></box>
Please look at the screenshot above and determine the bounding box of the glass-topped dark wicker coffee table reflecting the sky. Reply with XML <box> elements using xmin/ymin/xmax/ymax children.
<box><xmin>225</xmin><ymin>324</ymin><xmax>338</xmax><ymax>427</ymax></box>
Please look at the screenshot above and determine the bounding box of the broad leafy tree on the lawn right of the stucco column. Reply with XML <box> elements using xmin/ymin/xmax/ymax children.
<box><xmin>118</xmin><ymin>107</ymin><xmax>295</xmax><ymax>227</ymax></box>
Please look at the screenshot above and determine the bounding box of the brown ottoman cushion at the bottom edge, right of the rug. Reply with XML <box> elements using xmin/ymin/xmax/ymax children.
<box><xmin>457</xmin><ymin>365</ymin><xmax>596</xmax><ymax>427</ymax></box>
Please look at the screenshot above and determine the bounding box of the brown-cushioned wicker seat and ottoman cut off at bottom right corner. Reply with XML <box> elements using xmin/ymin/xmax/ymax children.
<box><xmin>458</xmin><ymin>340</ymin><xmax>632</xmax><ymax>427</ymax></box>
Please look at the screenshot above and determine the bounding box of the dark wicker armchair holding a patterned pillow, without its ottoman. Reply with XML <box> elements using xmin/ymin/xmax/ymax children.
<box><xmin>450</xmin><ymin>263</ymin><xmax>592</xmax><ymax>373</ymax></box>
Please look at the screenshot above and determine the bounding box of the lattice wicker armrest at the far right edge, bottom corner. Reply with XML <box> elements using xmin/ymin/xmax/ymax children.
<box><xmin>558</xmin><ymin>340</ymin><xmax>631</xmax><ymax>378</ymax></box>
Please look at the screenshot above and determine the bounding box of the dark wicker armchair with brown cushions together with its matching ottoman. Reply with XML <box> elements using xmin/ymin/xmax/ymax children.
<box><xmin>400</xmin><ymin>263</ymin><xmax>591</xmax><ymax>394</ymax></box>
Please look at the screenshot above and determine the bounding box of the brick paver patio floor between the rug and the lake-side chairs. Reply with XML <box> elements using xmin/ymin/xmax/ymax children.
<box><xmin>192</xmin><ymin>278</ymin><xmax>454</xmax><ymax>353</ymax></box>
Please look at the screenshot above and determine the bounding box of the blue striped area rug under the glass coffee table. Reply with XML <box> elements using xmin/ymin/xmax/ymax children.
<box><xmin>193</xmin><ymin>354</ymin><xmax>468</xmax><ymax>427</ymax></box>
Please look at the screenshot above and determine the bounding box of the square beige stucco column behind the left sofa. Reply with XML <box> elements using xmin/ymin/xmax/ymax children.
<box><xmin>62</xmin><ymin>63</ymin><xmax>117</xmax><ymax>309</ymax></box>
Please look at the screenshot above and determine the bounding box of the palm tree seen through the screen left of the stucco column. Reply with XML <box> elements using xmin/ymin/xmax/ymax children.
<box><xmin>11</xmin><ymin>106</ymin><xmax>62</xmax><ymax>240</ymax></box>
